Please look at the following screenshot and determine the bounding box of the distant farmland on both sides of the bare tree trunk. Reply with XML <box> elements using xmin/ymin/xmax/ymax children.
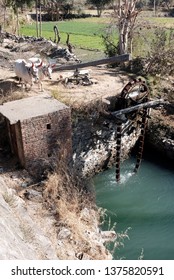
<box><xmin>20</xmin><ymin>12</ymin><xmax>174</xmax><ymax>56</ymax></box>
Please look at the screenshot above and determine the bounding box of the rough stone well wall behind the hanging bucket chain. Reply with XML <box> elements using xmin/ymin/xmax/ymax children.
<box><xmin>72</xmin><ymin>111</ymin><xmax>140</xmax><ymax>176</ymax></box>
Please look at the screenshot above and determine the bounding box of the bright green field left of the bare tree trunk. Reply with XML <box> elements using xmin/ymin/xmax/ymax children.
<box><xmin>20</xmin><ymin>18</ymin><xmax>113</xmax><ymax>51</ymax></box>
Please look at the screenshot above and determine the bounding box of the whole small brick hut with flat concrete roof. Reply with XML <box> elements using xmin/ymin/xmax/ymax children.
<box><xmin>0</xmin><ymin>94</ymin><xmax>72</xmax><ymax>176</ymax></box>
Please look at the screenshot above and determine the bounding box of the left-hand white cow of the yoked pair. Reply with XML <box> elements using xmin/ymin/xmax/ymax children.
<box><xmin>14</xmin><ymin>59</ymin><xmax>38</xmax><ymax>89</ymax></box>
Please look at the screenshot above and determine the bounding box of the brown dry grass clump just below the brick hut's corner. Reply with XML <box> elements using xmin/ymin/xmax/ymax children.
<box><xmin>44</xmin><ymin>165</ymin><xmax>95</xmax><ymax>227</ymax></box>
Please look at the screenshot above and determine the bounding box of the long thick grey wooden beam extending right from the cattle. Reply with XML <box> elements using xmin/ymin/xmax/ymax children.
<box><xmin>53</xmin><ymin>54</ymin><xmax>131</xmax><ymax>71</ymax></box>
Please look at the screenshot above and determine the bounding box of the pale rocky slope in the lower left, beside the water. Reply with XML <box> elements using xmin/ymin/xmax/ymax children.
<box><xmin>0</xmin><ymin>171</ymin><xmax>116</xmax><ymax>260</ymax></box>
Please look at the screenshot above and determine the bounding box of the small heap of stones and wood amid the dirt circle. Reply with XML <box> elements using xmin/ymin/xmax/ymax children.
<box><xmin>59</xmin><ymin>69</ymin><xmax>97</xmax><ymax>86</ymax></box>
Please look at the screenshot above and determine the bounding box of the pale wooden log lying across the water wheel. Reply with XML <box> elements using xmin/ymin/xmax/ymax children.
<box><xmin>111</xmin><ymin>99</ymin><xmax>170</xmax><ymax>117</ymax></box>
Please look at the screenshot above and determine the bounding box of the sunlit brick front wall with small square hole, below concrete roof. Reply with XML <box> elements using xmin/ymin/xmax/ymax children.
<box><xmin>21</xmin><ymin>108</ymin><xmax>72</xmax><ymax>177</ymax></box>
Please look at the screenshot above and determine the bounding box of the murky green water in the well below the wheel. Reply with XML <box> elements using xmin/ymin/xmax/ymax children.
<box><xmin>94</xmin><ymin>153</ymin><xmax>174</xmax><ymax>260</ymax></box>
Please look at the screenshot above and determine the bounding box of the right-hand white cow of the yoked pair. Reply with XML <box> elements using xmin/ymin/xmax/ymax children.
<box><xmin>29</xmin><ymin>57</ymin><xmax>55</xmax><ymax>91</ymax></box>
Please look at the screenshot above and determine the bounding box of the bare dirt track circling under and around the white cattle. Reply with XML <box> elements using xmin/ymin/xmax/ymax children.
<box><xmin>0</xmin><ymin>38</ymin><xmax>128</xmax><ymax>107</ymax></box>
